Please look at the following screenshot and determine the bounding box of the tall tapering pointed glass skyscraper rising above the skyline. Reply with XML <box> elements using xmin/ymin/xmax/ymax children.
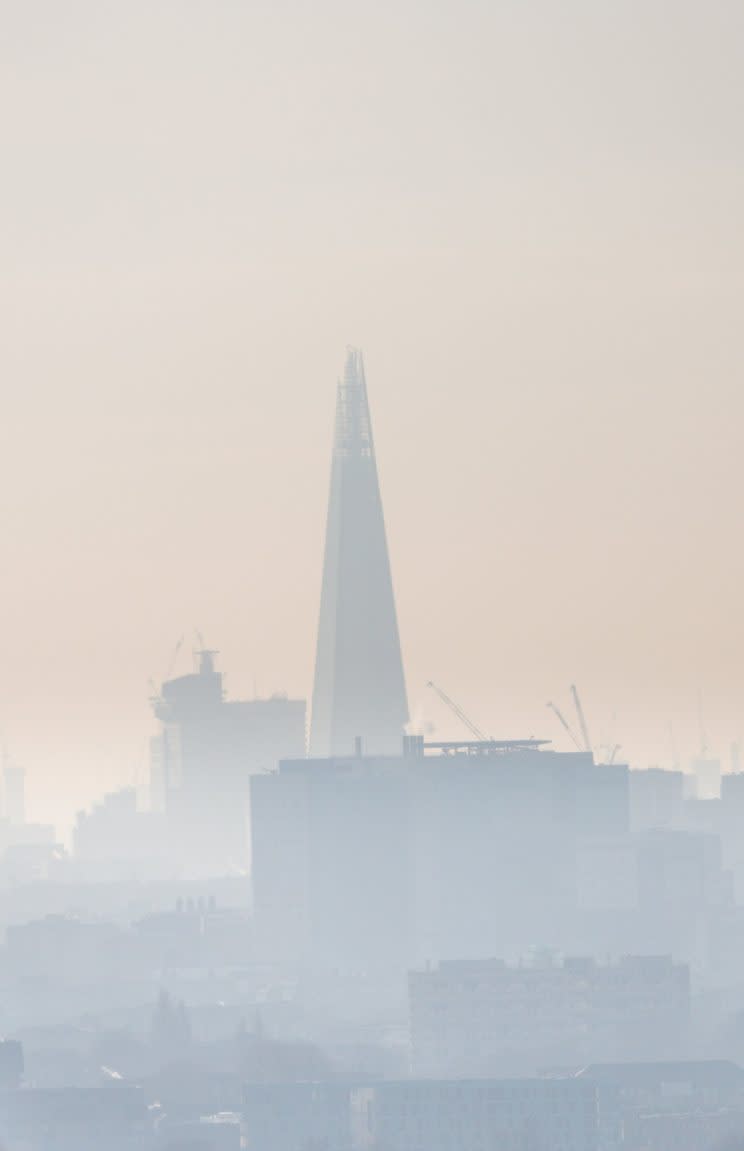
<box><xmin>310</xmin><ymin>349</ymin><xmax>408</xmax><ymax>756</ymax></box>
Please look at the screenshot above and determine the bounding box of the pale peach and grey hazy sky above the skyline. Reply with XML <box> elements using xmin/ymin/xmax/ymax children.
<box><xmin>0</xmin><ymin>0</ymin><xmax>744</xmax><ymax>820</ymax></box>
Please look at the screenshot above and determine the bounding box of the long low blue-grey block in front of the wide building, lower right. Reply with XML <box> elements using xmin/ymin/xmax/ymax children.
<box><xmin>409</xmin><ymin>956</ymin><xmax>690</xmax><ymax>1077</ymax></box>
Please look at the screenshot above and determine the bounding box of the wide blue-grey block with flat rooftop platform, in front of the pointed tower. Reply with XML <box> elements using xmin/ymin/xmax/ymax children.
<box><xmin>251</xmin><ymin>740</ymin><xmax>628</xmax><ymax>971</ymax></box>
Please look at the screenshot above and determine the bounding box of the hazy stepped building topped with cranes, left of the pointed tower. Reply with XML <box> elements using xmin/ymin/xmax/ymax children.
<box><xmin>152</xmin><ymin>650</ymin><xmax>305</xmax><ymax>875</ymax></box>
